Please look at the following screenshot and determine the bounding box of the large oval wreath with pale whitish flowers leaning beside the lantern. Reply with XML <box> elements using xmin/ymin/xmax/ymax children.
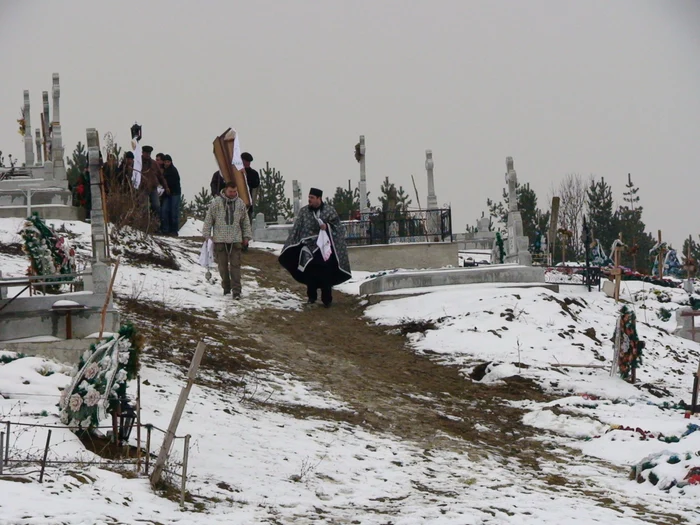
<box><xmin>59</xmin><ymin>323</ymin><xmax>141</xmax><ymax>430</ymax></box>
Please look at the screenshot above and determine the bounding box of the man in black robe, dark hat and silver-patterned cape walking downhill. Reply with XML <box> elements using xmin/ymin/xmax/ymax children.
<box><xmin>279</xmin><ymin>188</ymin><xmax>352</xmax><ymax>308</ymax></box>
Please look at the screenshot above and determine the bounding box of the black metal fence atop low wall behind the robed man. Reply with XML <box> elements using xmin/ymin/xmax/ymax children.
<box><xmin>343</xmin><ymin>208</ymin><xmax>452</xmax><ymax>246</ymax></box>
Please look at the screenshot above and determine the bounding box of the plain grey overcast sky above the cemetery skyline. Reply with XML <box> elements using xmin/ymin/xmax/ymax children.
<box><xmin>0</xmin><ymin>0</ymin><xmax>700</xmax><ymax>248</ymax></box>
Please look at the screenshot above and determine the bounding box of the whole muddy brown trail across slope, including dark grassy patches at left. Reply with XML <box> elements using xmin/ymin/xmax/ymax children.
<box><xmin>120</xmin><ymin>250</ymin><xmax>682</xmax><ymax>524</ymax></box>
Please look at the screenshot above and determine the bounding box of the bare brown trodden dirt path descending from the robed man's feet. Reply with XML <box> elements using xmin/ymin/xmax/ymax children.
<box><xmin>245</xmin><ymin>253</ymin><xmax>545</xmax><ymax>461</ymax></box>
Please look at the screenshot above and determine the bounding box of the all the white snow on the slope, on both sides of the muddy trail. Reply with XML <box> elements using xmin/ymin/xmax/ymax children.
<box><xmin>0</xmin><ymin>219</ymin><xmax>700</xmax><ymax>525</ymax></box>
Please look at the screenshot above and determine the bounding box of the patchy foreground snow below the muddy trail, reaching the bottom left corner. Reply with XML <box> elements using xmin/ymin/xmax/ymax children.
<box><xmin>0</xmin><ymin>352</ymin><xmax>689</xmax><ymax>525</ymax></box>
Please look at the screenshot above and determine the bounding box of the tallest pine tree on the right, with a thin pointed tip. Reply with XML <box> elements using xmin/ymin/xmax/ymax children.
<box><xmin>617</xmin><ymin>174</ymin><xmax>655</xmax><ymax>273</ymax></box>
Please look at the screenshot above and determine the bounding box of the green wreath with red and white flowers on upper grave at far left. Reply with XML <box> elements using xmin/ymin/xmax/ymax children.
<box><xmin>21</xmin><ymin>212</ymin><xmax>75</xmax><ymax>292</ymax></box>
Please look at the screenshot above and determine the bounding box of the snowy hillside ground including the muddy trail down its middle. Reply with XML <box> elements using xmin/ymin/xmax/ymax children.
<box><xmin>0</xmin><ymin>215</ymin><xmax>700</xmax><ymax>525</ymax></box>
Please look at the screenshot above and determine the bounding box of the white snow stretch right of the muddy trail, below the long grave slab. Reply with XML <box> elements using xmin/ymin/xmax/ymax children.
<box><xmin>366</xmin><ymin>274</ymin><xmax>700</xmax><ymax>497</ymax></box>
